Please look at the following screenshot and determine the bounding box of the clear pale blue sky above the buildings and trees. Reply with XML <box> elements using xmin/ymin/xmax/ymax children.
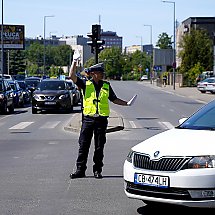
<box><xmin>0</xmin><ymin>0</ymin><xmax>215</xmax><ymax>47</ymax></box>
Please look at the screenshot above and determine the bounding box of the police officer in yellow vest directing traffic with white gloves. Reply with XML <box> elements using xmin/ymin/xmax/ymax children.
<box><xmin>69</xmin><ymin>51</ymin><xmax>132</xmax><ymax>179</ymax></box>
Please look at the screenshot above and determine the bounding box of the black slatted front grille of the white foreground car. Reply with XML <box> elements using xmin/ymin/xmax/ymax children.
<box><xmin>133</xmin><ymin>153</ymin><xmax>191</xmax><ymax>171</ymax></box>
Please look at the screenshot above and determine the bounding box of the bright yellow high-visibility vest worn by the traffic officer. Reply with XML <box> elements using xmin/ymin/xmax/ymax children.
<box><xmin>83</xmin><ymin>81</ymin><xmax>110</xmax><ymax>116</ymax></box>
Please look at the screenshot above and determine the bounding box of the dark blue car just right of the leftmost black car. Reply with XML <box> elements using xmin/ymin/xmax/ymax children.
<box><xmin>8</xmin><ymin>80</ymin><xmax>24</xmax><ymax>107</ymax></box>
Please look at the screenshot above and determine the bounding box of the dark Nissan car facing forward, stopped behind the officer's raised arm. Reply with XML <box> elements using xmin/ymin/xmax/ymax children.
<box><xmin>32</xmin><ymin>79</ymin><xmax>73</xmax><ymax>114</ymax></box>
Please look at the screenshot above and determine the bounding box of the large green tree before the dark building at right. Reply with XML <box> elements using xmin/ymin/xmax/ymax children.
<box><xmin>179</xmin><ymin>29</ymin><xmax>213</xmax><ymax>85</ymax></box>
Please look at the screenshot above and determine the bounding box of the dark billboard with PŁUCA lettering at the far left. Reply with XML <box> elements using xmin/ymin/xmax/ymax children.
<box><xmin>0</xmin><ymin>25</ymin><xmax>25</xmax><ymax>49</ymax></box>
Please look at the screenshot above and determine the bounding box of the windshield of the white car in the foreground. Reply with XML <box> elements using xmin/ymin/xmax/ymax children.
<box><xmin>177</xmin><ymin>100</ymin><xmax>215</xmax><ymax>130</ymax></box>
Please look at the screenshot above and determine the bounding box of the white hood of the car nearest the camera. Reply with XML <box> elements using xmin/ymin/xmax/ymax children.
<box><xmin>132</xmin><ymin>128</ymin><xmax>215</xmax><ymax>158</ymax></box>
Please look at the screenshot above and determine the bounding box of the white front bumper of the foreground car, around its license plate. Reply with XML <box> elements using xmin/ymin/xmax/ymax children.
<box><xmin>123</xmin><ymin>161</ymin><xmax>215</xmax><ymax>208</ymax></box>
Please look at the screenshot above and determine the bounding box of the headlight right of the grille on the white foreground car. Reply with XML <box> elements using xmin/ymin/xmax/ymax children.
<box><xmin>188</xmin><ymin>155</ymin><xmax>215</xmax><ymax>169</ymax></box>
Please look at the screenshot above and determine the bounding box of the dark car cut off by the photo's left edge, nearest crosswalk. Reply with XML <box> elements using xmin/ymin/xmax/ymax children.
<box><xmin>0</xmin><ymin>78</ymin><xmax>14</xmax><ymax>114</ymax></box>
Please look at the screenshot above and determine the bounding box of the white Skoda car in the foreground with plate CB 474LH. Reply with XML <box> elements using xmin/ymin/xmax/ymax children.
<box><xmin>123</xmin><ymin>100</ymin><xmax>215</xmax><ymax>208</ymax></box>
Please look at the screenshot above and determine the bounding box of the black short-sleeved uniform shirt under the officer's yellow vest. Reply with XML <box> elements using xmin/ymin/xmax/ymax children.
<box><xmin>76</xmin><ymin>77</ymin><xmax>117</xmax><ymax>102</ymax></box>
